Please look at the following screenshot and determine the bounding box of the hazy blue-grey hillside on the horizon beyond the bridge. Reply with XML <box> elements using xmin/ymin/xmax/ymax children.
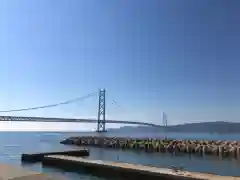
<box><xmin>109</xmin><ymin>121</ymin><xmax>240</xmax><ymax>133</ymax></box>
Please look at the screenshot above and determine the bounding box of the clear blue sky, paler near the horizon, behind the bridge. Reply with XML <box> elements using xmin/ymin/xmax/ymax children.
<box><xmin>0</xmin><ymin>0</ymin><xmax>240</xmax><ymax>130</ymax></box>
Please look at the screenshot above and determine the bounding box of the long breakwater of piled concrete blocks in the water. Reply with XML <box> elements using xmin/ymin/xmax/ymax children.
<box><xmin>61</xmin><ymin>136</ymin><xmax>240</xmax><ymax>158</ymax></box>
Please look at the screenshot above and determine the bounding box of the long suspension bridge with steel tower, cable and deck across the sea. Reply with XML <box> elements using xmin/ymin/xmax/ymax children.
<box><xmin>0</xmin><ymin>89</ymin><xmax>163</xmax><ymax>133</ymax></box>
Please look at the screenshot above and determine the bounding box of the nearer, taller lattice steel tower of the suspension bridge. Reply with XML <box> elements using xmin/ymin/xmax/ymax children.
<box><xmin>97</xmin><ymin>89</ymin><xmax>106</xmax><ymax>133</ymax></box>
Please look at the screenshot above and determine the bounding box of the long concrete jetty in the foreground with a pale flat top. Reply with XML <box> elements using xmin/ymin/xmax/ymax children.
<box><xmin>31</xmin><ymin>155</ymin><xmax>240</xmax><ymax>180</ymax></box>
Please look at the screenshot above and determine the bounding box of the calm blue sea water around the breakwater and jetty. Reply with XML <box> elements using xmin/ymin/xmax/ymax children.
<box><xmin>0</xmin><ymin>132</ymin><xmax>240</xmax><ymax>180</ymax></box>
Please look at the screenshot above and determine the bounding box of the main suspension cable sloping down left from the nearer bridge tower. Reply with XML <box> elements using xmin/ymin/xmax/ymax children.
<box><xmin>0</xmin><ymin>92</ymin><xmax>97</xmax><ymax>113</ymax></box>
